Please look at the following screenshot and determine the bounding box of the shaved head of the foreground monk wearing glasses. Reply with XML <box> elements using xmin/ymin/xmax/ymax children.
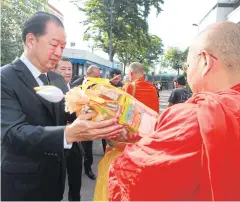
<box><xmin>187</xmin><ymin>21</ymin><xmax>240</xmax><ymax>92</ymax></box>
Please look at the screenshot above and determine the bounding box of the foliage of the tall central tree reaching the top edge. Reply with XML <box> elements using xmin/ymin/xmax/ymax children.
<box><xmin>75</xmin><ymin>0</ymin><xmax>163</xmax><ymax>68</ymax></box>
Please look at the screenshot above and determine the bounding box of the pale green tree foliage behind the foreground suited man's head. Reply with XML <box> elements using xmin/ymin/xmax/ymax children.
<box><xmin>1</xmin><ymin>0</ymin><xmax>47</xmax><ymax>65</ymax></box>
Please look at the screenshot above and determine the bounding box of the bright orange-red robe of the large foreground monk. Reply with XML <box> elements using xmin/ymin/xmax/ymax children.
<box><xmin>108</xmin><ymin>84</ymin><xmax>240</xmax><ymax>201</ymax></box>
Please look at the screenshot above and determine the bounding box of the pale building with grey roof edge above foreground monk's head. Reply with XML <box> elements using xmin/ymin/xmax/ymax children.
<box><xmin>198</xmin><ymin>0</ymin><xmax>240</xmax><ymax>31</ymax></box>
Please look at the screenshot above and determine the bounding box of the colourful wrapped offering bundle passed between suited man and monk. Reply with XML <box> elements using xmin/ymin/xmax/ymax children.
<box><xmin>65</xmin><ymin>78</ymin><xmax>158</xmax><ymax>142</ymax></box>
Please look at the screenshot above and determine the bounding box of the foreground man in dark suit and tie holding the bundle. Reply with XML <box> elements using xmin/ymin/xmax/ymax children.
<box><xmin>1</xmin><ymin>12</ymin><xmax>122</xmax><ymax>201</ymax></box>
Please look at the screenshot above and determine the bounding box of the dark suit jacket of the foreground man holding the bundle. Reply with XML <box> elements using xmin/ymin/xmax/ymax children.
<box><xmin>1</xmin><ymin>60</ymin><xmax>67</xmax><ymax>201</ymax></box>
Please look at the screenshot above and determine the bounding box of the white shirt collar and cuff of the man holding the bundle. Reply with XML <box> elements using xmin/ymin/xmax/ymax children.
<box><xmin>20</xmin><ymin>53</ymin><xmax>72</xmax><ymax>149</ymax></box>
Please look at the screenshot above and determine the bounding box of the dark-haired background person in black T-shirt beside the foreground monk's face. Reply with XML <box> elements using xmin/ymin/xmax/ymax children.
<box><xmin>168</xmin><ymin>76</ymin><xmax>191</xmax><ymax>107</ymax></box>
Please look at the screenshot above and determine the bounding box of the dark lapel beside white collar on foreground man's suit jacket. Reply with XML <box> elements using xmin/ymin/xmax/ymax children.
<box><xmin>13</xmin><ymin>60</ymin><xmax>54</xmax><ymax>119</ymax></box>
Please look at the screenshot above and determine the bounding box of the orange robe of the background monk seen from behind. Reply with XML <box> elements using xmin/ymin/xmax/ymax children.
<box><xmin>125</xmin><ymin>77</ymin><xmax>159</xmax><ymax>113</ymax></box>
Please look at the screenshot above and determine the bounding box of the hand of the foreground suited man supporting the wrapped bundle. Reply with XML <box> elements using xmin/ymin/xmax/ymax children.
<box><xmin>65</xmin><ymin>113</ymin><xmax>123</xmax><ymax>144</ymax></box>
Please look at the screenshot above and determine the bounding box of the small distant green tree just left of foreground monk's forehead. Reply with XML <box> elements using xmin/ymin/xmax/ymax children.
<box><xmin>164</xmin><ymin>47</ymin><xmax>188</xmax><ymax>75</ymax></box>
